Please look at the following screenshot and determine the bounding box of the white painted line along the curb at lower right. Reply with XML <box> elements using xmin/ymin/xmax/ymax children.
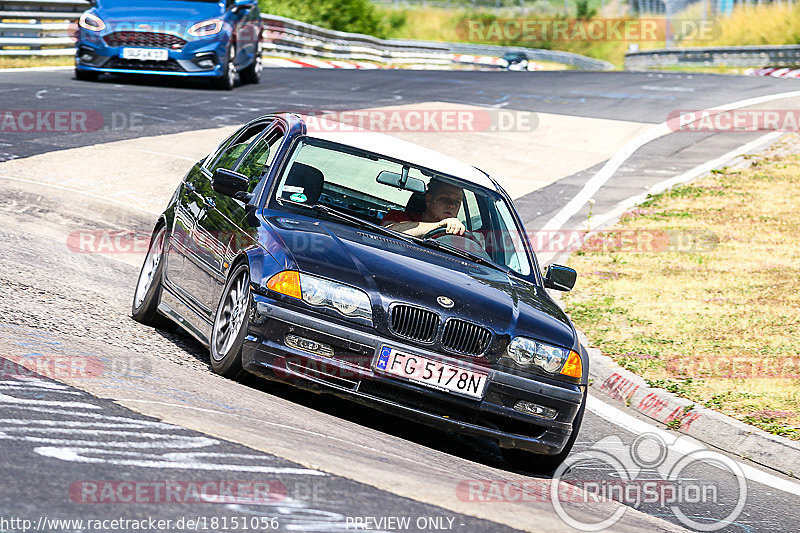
<box><xmin>586</xmin><ymin>395</ymin><xmax>800</xmax><ymax>496</ymax></box>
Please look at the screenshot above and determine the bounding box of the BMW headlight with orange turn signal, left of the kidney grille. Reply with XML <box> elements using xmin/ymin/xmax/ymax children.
<box><xmin>267</xmin><ymin>270</ymin><xmax>372</xmax><ymax>320</ymax></box>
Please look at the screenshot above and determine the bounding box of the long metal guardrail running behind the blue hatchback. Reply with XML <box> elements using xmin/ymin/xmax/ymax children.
<box><xmin>0</xmin><ymin>0</ymin><xmax>613</xmax><ymax>70</ymax></box>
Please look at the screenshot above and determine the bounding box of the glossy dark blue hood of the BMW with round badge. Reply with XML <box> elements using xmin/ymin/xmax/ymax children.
<box><xmin>269</xmin><ymin>217</ymin><xmax>575</xmax><ymax>348</ymax></box>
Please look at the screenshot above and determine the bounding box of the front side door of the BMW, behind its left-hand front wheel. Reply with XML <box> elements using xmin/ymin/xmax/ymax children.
<box><xmin>181</xmin><ymin>119</ymin><xmax>273</xmax><ymax>330</ymax></box>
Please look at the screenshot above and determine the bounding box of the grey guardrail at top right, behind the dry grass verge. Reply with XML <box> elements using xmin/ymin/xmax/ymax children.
<box><xmin>625</xmin><ymin>45</ymin><xmax>800</xmax><ymax>70</ymax></box>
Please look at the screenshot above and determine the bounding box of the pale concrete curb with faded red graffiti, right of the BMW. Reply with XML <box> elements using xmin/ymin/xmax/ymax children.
<box><xmin>578</xmin><ymin>332</ymin><xmax>800</xmax><ymax>478</ymax></box>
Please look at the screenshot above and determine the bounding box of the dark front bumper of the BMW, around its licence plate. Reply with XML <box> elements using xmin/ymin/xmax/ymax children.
<box><xmin>242</xmin><ymin>294</ymin><xmax>586</xmax><ymax>454</ymax></box>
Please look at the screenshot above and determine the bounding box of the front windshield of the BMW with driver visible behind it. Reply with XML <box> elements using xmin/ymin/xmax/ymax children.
<box><xmin>273</xmin><ymin>138</ymin><xmax>531</xmax><ymax>276</ymax></box>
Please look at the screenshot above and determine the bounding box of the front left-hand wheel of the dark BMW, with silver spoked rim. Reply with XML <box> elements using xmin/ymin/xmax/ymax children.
<box><xmin>210</xmin><ymin>263</ymin><xmax>252</xmax><ymax>379</ymax></box>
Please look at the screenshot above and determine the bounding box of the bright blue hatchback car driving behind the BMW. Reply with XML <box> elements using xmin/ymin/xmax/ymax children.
<box><xmin>75</xmin><ymin>0</ymin><xmax>262</xmax><ymax>89</ymax></box>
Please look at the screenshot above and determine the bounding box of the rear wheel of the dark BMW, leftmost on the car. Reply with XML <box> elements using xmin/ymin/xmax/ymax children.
<box><xmin>131</xmin><ymin>225</ymin><xmax>170</xmax><ymax>328</ymax></box>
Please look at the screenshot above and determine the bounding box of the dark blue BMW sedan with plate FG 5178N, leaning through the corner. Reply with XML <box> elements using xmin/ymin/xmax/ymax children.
<box><xmin>132</xmin><ymin>114</ymin><xmax>589</xmax><ymax>470</ymax></box>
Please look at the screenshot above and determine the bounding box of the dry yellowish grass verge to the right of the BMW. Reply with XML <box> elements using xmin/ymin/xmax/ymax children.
<box><xmin>565</xmin><ymin>134</ymin><xmax>800</xmax><ymax>440</ymax></box>
